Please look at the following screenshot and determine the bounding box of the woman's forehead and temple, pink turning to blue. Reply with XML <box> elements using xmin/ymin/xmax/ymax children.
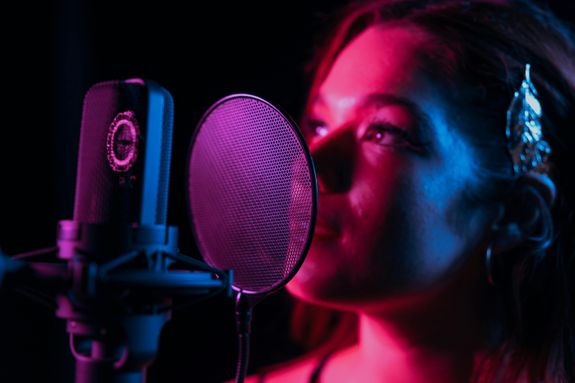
<box><xmin>310</xmin><ymin>22</ymin><xmax>478</xmax><ymax>166</ymax></box>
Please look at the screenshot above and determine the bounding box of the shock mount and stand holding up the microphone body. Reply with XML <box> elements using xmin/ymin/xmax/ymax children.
<box><xmin>0</xmin><ymin>220</ymin><xmax>232</xmax><ymax>383</ymax></box>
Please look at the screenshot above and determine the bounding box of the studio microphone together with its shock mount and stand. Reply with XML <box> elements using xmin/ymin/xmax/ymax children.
<box><xmin>0</xmin><ymin>79</ymin><xmax>232</xmax><ymax>383</ymax></box>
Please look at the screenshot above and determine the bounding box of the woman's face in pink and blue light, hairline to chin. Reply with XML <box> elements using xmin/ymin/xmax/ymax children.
<box><xmin>288</xmin><ymin>24</ymin><xmax>500</xmax><ymax>309</ymax></box>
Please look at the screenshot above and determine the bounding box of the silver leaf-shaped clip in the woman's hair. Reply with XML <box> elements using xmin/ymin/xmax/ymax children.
<box><xmin>505</xmin><ymin>64</ymin><xmax>551</xmax><ymax>176</ymax></box>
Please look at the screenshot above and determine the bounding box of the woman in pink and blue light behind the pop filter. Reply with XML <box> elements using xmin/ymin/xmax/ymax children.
<box><xmin>248</xmin><ymin>0</ymin><xmax>575</xmax><ymax>383</ymax></box>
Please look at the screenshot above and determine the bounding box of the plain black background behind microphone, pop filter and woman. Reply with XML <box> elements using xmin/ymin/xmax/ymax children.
<box><xmin>0</xmin><ymin>0</ymin><xmax>575</xmax><ymax>383</ymax></box>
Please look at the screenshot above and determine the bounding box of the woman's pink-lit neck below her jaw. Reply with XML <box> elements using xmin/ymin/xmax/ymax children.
<box><xmin>332</xmin><ymin>280</ymin><xmax>490</xmax><ymax>383</ymax></box>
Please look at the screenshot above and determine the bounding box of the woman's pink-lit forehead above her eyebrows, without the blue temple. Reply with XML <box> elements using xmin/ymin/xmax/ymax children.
<box><xmin>319</xmin><ymin>23</ymin><xmax>440</xmax><ymax>112</ymax></box>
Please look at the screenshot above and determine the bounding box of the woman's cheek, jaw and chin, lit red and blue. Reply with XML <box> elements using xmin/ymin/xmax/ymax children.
<box><xmin>288</xmin><ymin>151</ymin><xmax>485</xmax><ymax>307</ymax></box>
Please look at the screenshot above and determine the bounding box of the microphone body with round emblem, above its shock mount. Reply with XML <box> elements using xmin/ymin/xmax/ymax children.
<box><xmin>74</xmin><ymin>79</ymin><xmax>174</xmax><ymax>225</ymax></box>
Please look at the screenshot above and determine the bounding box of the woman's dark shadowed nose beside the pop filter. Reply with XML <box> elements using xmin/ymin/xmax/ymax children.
<box><xmin>309</xmin><ymin>128</ymin><xmax>356</xmax><ymax>193</ymax></box>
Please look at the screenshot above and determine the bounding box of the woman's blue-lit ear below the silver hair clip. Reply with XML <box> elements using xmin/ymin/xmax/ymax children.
<box><xmin>492</xmin><ymin>174</ymin><xmax>556</xmax><ymax>253</ymax></box>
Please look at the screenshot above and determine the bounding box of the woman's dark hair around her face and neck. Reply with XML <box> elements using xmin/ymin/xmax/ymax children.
<box><xmin>292</xmin><ymin>0</ymin><xmax>575</xmax><ymax>382</ymax></box>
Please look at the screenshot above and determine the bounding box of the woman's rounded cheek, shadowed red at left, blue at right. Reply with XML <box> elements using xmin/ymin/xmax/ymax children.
<box><xmin>354</xmin><ymin>161</ymin><xmax>483</xmax><ymax>293</ymax></box>
